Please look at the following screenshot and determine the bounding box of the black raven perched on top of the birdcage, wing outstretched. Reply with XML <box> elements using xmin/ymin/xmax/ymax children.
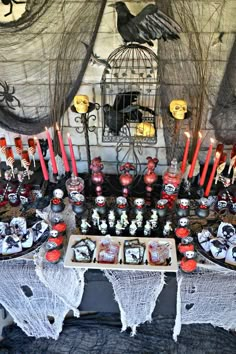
<box><xmin>109</xmin><ymin>1</ymin><xmax>181</xmax><ymax>46</ymax></box>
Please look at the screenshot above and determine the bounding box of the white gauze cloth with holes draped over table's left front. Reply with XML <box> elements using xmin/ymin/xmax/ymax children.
<box><xmin>0</xmin><ymin>260</ymin><xmax>81</xmax><ymax>339</ymax></box>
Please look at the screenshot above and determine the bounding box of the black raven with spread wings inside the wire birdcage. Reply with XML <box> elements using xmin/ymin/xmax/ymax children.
<box><xmin>103</xmin><ymin>91</ymin><xmax>155</xmax><ymax>135</ymax></box>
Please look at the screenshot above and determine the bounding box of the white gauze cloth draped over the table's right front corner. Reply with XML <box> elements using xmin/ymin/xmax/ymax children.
<box><xmin>173</xmin><ymin>265</ymin><xmax>236</xmax><ymax>340</ymax></box>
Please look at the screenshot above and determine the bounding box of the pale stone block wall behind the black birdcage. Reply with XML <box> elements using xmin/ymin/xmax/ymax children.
<box><xmin>0</xmin><ymin>0</ymin><xmax>236</xmax><ymax>173</ymax></box>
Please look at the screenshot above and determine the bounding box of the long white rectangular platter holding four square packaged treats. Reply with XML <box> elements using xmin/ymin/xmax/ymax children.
<box><xmin>64</xmin><ymin>235</ymin><xmax>178</xmax><ymax>272</ymax></box>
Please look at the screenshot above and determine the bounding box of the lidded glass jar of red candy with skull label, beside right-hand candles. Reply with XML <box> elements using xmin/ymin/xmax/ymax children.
<box><xmin>161</xmin><ymin>158</ymin><xmax>182</xmax><ymax>208</ymax></box>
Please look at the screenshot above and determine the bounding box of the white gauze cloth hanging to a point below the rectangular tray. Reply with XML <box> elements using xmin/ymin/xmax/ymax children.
<box><xmin>104</xmin><ymin>270</ymin><xmax>165</xmax><ymax>335</ymax></box>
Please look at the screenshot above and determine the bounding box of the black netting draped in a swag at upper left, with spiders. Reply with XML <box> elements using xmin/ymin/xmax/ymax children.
<box><xmin>0</xmin><ymin>0</ymin><xmax>106</xmax><ymax>135</ymax></box>
